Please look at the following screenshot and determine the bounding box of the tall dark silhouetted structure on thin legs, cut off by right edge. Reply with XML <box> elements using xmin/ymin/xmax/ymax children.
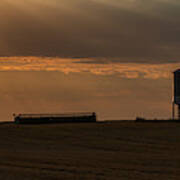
<box><xmin>173</xmin><ymin>69</ymin><xmax>180</xmax><ymax>120</ymax></box>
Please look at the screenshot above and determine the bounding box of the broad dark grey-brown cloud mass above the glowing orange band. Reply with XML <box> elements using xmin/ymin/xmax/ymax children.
<box><xmin>0</xmin><ymin>0</ymin><xmax>180</xmax><ymax>63</ymax></box>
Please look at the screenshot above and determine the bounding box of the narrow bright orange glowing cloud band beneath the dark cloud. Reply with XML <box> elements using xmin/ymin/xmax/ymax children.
<box><xmin>0</xmin><ymin>57</ymin><xmax>180</xmax><ymax>79</ymax></box>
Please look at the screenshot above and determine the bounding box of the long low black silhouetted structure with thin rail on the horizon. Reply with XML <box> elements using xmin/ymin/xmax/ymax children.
<box><xmin>14</xmin><ymin>112</ymin><xmax>96</xmax><ymax>124</ymax></box>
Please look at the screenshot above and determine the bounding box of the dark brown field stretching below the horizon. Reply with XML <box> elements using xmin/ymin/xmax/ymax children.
<box><xmin>0</xmin><ymin>122</ymin><xmax>180</xmax><ymax>180</ymax></box>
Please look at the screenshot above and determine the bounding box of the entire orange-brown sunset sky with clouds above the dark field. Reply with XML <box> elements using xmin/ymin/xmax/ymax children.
<box><xmin>0</xmin><ymin>0</ymin><xmax>180</xmax><ymax>121</ymax></box>
